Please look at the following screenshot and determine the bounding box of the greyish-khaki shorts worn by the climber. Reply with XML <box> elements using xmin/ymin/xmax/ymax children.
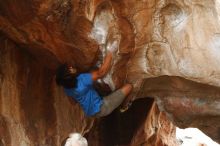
<box><xmin>95</xmin><ymin>89</ymin><xmax>125</xmax><ymax>117</ymax></box>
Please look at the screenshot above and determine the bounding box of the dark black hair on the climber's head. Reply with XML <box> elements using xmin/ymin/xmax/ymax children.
<box><xmin>56</xmin><ymin>64</ymin><xmax>77</xmax><ymax>88</ymax></box>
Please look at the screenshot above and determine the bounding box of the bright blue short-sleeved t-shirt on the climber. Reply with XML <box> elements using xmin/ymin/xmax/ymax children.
<box><xmin>64</xmin><ymin>73</ymin><xmax>103</xmax><ymax>116</ymax></box>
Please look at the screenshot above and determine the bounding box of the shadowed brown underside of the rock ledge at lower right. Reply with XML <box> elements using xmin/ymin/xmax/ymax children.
<box><xmin>139</xmin><ymin>76</ymin><xmax>220</xmax><ymax>141</ymax></box>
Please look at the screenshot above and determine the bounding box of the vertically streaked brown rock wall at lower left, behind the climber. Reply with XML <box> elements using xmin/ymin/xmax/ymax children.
<box><xmin>0</xmin><ymin>37</ymin><xmax>93</xmax><ymax>146</ymax></box>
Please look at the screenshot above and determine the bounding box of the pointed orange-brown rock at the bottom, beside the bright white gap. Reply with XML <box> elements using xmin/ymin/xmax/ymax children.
<box><xmin>131</xmin><ymin>103</ymin><xmax>177</xmax><ymax>146</ymax></box>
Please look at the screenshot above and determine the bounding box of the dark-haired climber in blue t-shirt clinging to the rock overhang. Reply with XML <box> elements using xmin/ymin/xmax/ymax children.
<box><xmin>56</xmin><ymin>42</ymin><xmax>132</xmax><ymax>117</ymax></box>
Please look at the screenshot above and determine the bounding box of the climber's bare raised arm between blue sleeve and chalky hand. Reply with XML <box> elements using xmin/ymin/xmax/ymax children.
<box><xmin>91</xmin><ymin>52</ymin><xmax>112</xmax><ymax>81</ymax></box>
